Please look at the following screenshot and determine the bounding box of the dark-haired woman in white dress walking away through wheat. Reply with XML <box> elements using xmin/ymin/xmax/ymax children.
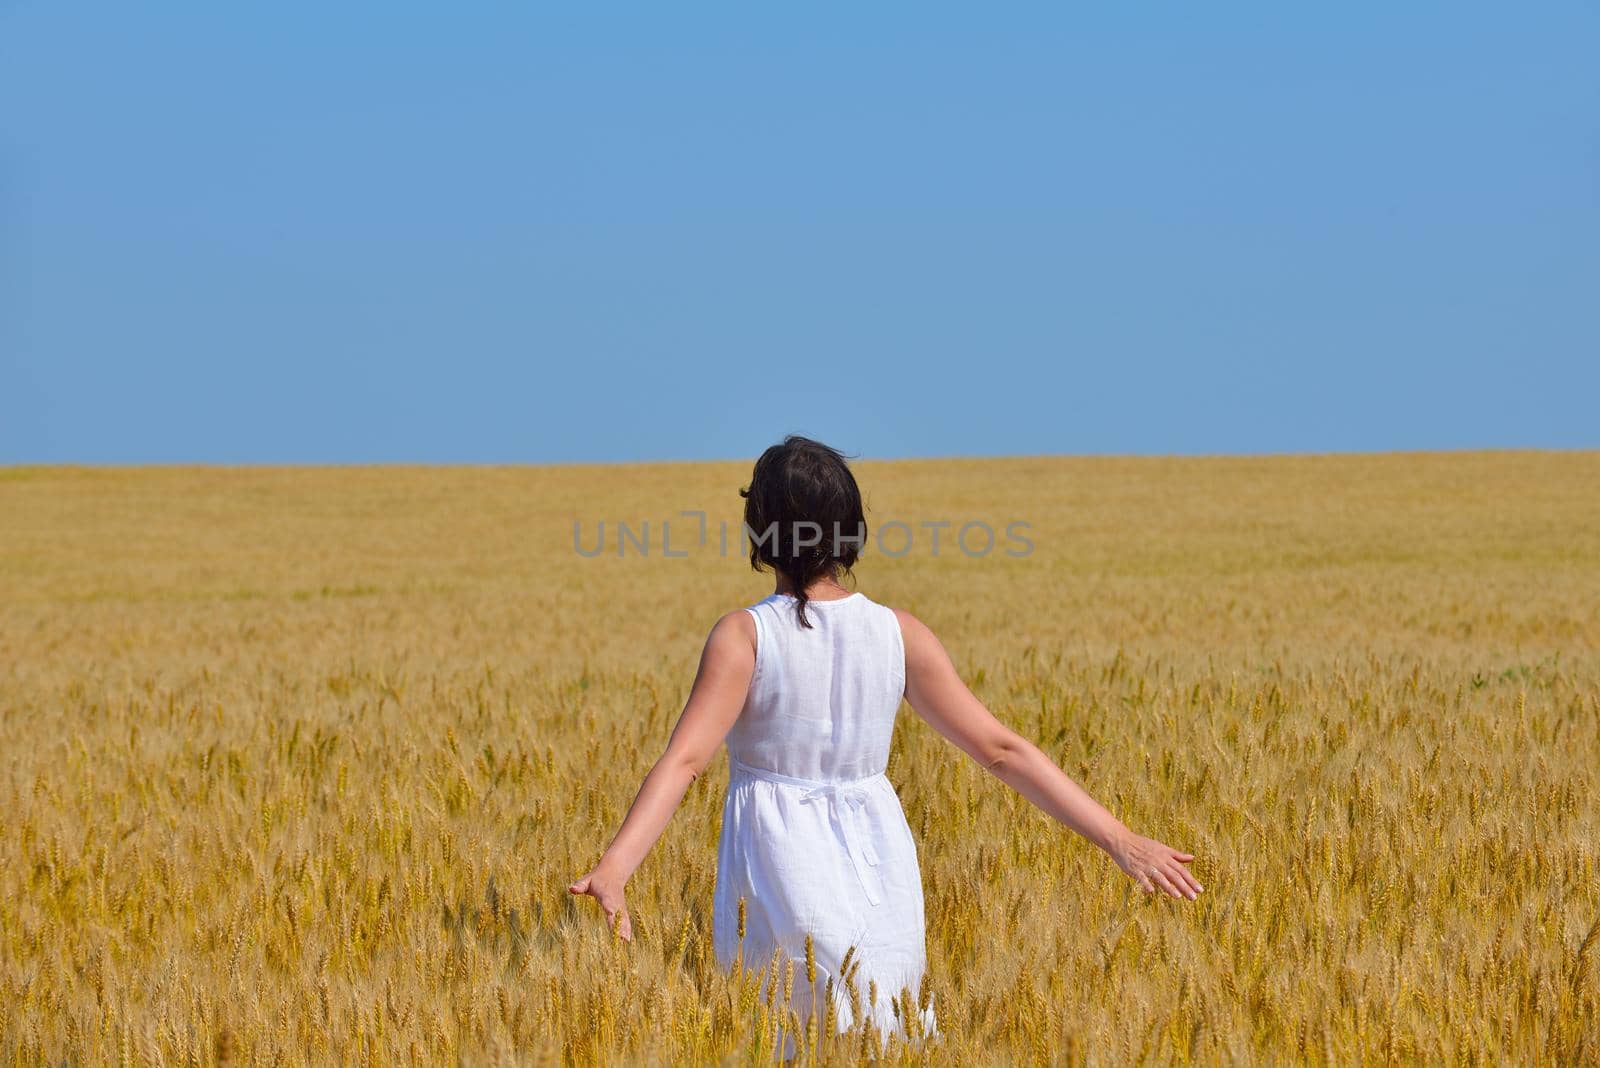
<box><xmin>568</xmin><ymin>436</ymin><xmax>1202</xmax><ymax>1055</ymax></box>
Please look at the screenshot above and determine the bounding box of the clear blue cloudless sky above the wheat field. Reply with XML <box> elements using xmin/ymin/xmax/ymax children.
<box><xmin>0</xmin><ymin>2</ymin><xmax>1600</xmax><ymax>464</ymax></box>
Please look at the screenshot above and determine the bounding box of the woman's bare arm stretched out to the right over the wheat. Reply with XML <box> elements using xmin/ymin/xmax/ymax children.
<box><xmin>894</xmin><ymin>609</ymin><xmax>1203</xmax><ymax>900</ymax></box>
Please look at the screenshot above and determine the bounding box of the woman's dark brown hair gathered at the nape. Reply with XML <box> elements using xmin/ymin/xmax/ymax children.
<box><xmin>739</xmin><ymin>433</ymin><xmax>867</xmax><ymax>627</ymax></box>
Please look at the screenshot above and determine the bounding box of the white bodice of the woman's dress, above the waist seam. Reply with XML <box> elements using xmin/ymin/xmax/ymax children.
<box><xmin>726</xmin><ymin>593</ymin><xmax>906</xmax><ymax>782</ymax></box>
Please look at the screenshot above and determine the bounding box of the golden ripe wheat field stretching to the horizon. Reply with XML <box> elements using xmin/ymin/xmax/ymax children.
<box><xmin>0</xmin><ymin>452</ymin><xmax>1600</xmax><ymax>1065</ymax></box>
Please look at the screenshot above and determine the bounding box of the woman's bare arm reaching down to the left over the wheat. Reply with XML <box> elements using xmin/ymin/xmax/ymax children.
<box><xmin>566</xmin><ymin>608</ymin><xmax>755</xmax><ymax>942</ymax></box>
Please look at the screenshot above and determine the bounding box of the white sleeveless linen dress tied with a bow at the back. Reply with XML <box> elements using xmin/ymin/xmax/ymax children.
<box><xmin>712</xmin><ymin>593</ymin><xmax>938</xmax><ymax>1057</ymax></box>
